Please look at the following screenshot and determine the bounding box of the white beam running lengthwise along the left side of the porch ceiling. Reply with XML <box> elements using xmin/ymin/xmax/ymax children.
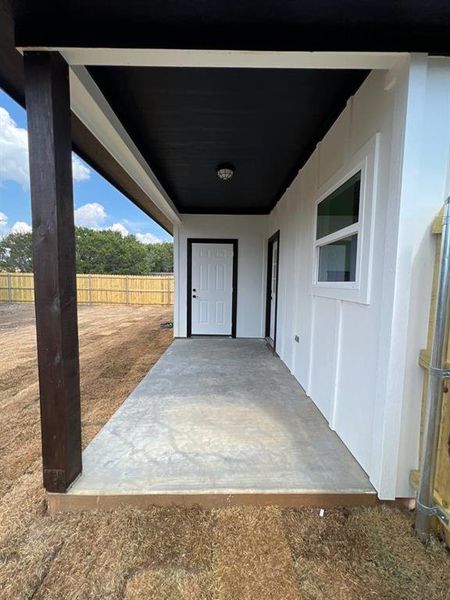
<box><xmin>70</xmin><ymin>67</ymin><xmax>181</xmax><ymax>224</ymax></box>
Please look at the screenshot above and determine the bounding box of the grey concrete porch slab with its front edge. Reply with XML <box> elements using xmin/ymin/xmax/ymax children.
<box><xmin>49</xmin><ymin>338</ymin><xmax>376</xmax><ymax>510</ymax></box>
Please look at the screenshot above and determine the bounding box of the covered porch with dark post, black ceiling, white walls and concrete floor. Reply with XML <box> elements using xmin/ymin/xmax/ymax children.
<box><xmin>5</xmin><ymin>0</ymin><xmax>450</xmax><ymax>506</ymax></box>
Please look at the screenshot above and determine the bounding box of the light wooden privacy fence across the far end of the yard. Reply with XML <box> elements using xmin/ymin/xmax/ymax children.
<box><xmin>0</xmin><ymin>273</ymin><xmax>174</xmax><ymax>305</ymax></box>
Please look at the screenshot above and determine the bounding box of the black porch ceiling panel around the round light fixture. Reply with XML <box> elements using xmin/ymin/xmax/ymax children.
<box><xmin>90</xmin><ymin>67</ymin><xmax>367</xmax><ymax>213</ymax></box>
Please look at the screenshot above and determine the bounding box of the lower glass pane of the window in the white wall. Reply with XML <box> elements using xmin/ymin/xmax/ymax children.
<box><xmin>318</xmin><ymin>234</ymin><xmax>358</xmax><ymax>281</ymax></box>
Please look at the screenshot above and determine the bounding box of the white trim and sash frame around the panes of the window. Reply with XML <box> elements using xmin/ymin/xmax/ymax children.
<box><xmin>312</xmin><ymin>134</ymin><xmax>380</xmax><ymax>304</ymax></box>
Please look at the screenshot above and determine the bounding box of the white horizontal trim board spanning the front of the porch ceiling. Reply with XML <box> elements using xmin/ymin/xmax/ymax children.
<box><xmin>18</xmin><ymin>46</ymin><xmax>409</xmax><ymax>70</ymax></box>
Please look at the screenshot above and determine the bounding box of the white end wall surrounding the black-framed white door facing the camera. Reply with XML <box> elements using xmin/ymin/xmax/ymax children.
<box><xmin>174</xmin><ymin>215</ymin><xmax>267</xmax><ymax>338</ymax></box>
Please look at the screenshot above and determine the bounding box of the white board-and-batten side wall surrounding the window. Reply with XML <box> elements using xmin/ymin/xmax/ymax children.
<box><xmin>268</xmin><ymin>71</ymin><xmax>406</xmax><ymax>496</ymax></box>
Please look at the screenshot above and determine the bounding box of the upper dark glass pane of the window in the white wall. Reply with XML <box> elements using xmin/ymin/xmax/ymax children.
<box><xmin>316</xmin><ymin>172</ymin><xmax>361</xmax><ymax>239</ymax></box>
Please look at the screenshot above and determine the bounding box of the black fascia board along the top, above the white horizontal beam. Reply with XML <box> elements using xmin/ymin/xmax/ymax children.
<box><xmin>12</xmin><ymin>0</ymin><xmax>450</xmax><ymax>53</ymax></box>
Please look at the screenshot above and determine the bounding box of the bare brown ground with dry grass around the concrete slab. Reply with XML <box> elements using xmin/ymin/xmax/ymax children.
<box><xmin>0</xmin><ymin>305</ymin><xmax>450</xmax><ymax>600</ymax></box>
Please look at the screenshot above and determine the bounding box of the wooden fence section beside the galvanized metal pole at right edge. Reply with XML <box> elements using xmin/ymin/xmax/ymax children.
<box><xmin>411</xmin><ymin>211</ymin><xmax>450</xmax><ymax>545</ymax></box>
